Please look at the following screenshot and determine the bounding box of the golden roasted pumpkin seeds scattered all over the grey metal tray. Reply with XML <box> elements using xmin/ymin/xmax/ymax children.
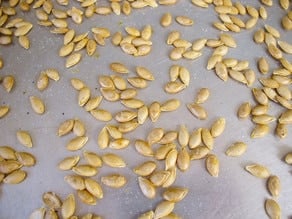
<box><xmin>0</xmin><ymin>0</ymin><xmax>292</xmax><ymax>219</ymax></box>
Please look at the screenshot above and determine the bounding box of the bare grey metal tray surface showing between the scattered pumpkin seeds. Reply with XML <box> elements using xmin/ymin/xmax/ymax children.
<box><xmin>0</xmin><ymin>0</ymin><xmax>292</xmax><ymax>219</ymax></box>
